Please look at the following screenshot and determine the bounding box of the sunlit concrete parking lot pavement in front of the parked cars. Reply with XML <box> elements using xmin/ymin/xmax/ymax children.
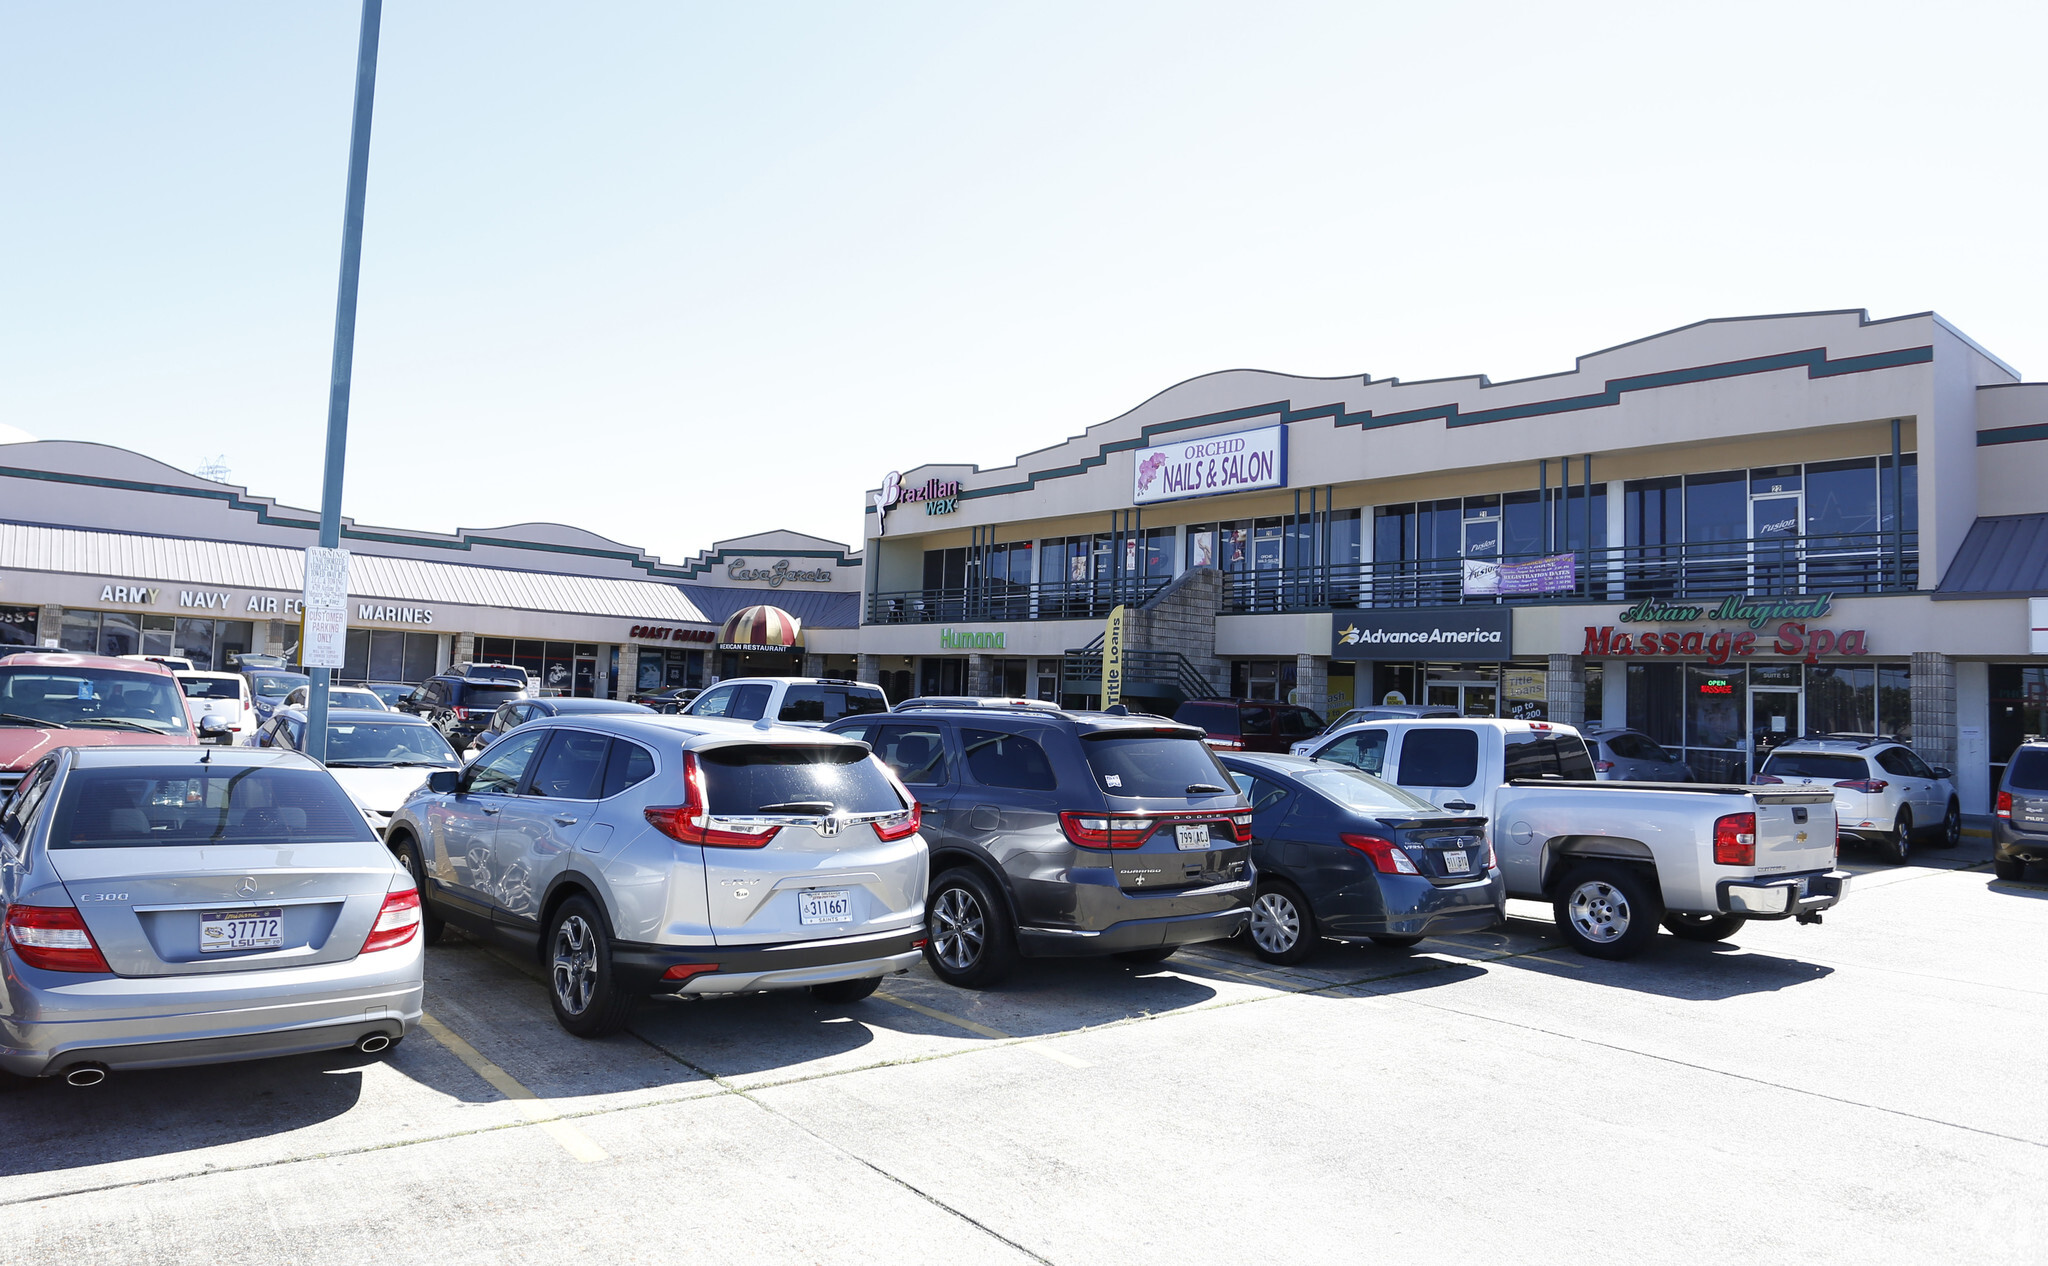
<box><xmin>0</xmin><ymin>838</ymin><xmax>2048</xmax><ymax>1264</ymax></box>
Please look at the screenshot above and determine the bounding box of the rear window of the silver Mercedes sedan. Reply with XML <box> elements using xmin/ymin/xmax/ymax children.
<box><xmin>49</xmin><ymin>764</ymin><xmax>377</xmax><ymax>848</ymax></box>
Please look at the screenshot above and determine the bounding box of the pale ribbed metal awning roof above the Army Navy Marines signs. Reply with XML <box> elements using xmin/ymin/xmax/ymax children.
<box><xmin>0</xmin><ymin>522</ymin><xmax>719</xmax><ymax>625</ymax></box>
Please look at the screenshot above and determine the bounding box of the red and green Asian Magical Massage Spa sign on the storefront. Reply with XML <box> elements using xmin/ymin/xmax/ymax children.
<box><xmin>1579</xmin><ymin>594</ymin><xmax>1870</xmax><ymax>664</ymax></box>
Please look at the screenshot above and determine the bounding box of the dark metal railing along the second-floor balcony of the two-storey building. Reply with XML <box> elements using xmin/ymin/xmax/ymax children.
<box><xmin>868</xmin><ymin>533</ymin><xmax>1919</xmax><ymax>625</ymax></box>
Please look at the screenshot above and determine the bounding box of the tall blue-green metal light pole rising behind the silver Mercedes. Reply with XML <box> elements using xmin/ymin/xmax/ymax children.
<box><xmin>305</xmin><ymin>0</ymin><xmax>383</xmax><ymax>760</ymax></box>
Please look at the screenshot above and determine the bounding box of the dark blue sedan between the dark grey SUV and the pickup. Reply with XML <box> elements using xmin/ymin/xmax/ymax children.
<box><xmin>1223</xmin><ymin>752</ymin><xmax>1507</xmax><ymax>963</ymax></box>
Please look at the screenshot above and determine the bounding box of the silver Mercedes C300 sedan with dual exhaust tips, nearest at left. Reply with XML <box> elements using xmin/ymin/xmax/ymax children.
<box><xmin>0</xmin><ymin>748</ymin><xmax>424</xmax><ymax>1086</ymax></box>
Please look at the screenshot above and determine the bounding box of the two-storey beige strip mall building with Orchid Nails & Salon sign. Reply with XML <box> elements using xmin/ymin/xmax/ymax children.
<box><xmin>858</xmin><ymin>311</ymin><xmax>2048</xmax><ymax>811</ymax></box>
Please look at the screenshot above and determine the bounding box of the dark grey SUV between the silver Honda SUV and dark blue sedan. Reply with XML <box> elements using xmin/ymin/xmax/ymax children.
<box><xmin>825</xmin><ymin>707</ymin><xmax>1253</xmax><ymax>987</ymax></box>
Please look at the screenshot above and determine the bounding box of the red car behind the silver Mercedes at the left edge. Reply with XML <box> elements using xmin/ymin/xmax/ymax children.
<box><xmin>0</xmin><ymin>651</ymin><xmax>203</xmax><ymax>801</ymax></box>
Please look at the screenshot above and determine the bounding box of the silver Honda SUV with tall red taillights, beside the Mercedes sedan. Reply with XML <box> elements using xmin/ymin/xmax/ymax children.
<box><xmin>385</xmin><ymin>713</ymin><xmax>928</xmax><ymax>1037</ymax></box>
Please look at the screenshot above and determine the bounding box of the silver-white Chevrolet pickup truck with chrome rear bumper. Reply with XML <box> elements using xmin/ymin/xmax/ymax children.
<box><xmin>1311</xmin><ymin>717</ymin><xmax>1849</xmax><ymax>959</ymax></box>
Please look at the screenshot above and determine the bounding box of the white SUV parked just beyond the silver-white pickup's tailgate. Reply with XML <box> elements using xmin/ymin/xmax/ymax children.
<box><xmin>1757</xmin><ymin>737</ymin><xmax>1962</xmax><ymax>862</ymax></box>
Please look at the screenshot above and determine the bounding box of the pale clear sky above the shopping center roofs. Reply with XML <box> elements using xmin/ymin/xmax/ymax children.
<box><xmin>0</xmin><ymin>0</ymin><xmax>2048</xmax><ymax>557</ymax></box>
